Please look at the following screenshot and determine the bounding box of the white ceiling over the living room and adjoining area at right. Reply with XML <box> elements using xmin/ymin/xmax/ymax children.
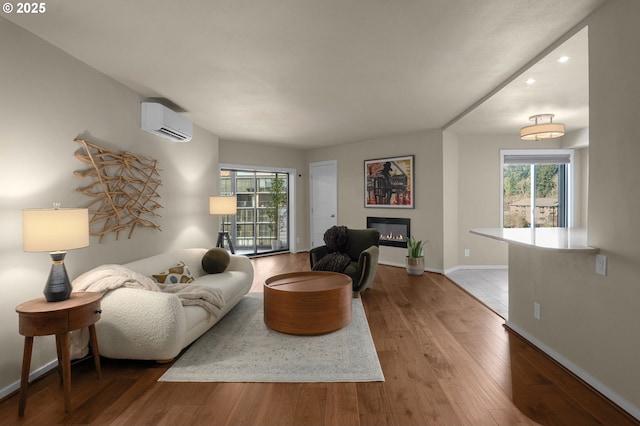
<box><xmin>2</xmin><ymin>0</ymin><xmax>607</xmax><ymax>149</ymax></box>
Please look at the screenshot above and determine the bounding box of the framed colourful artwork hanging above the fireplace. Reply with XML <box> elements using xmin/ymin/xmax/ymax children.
<box><xmin>364</xmin><ymin>155</ymin><xmax>414</xmax><ymax>209</ymax></box>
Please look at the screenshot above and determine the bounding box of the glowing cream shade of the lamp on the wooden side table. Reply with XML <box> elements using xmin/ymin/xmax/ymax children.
<box><xmin>22</xmin><ymin>208</ymin><xmax>89</xmax><ymax>252</ymax></box>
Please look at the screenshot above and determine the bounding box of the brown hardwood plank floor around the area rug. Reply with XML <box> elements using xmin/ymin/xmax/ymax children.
<box><xmin>0</xmin><ymin>253</ymin><xmax>639</xmax><ymax>425</ymax></box>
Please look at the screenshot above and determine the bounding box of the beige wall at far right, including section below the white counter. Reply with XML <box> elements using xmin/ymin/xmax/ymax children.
<box><xmin>509</xmin><ymin>0</ymin><xmax>640</xmax><ymax>418</ymax></box>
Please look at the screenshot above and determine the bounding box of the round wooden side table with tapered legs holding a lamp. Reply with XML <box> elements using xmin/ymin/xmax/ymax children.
<box><xmin>16</xmin><ymin>292</ymin><xmax>102</xmax><ymax>416</ymax></box>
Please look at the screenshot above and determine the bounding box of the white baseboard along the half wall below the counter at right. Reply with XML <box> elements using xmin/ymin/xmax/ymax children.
<box><xmin>505</xmin><ymin>320</ymin><xmax>640</xmax><ymax>420</ymax></box>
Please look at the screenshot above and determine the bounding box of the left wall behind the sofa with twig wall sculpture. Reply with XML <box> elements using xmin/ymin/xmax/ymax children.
<box><xmin>0</xmin><ymin>18</ymin><xmax>218</xmax><ymax>396</ymax></box>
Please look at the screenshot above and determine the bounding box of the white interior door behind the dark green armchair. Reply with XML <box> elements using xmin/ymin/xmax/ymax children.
<box><xmin>309</xmin><ymin>160</ymin><xmax>338</xmax><ymax>248</ymax></box>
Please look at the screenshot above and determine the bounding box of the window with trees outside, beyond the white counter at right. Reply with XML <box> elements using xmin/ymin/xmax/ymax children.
<box><xmin>500</xmin><ymin>150</ymin><xmax>573</xmax><ymax>228</ymax></box>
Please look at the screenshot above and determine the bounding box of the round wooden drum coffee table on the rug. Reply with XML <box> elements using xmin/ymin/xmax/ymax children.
<box><xmin>264</xmin><ymin>271</ymin><xmax>353</xmax><ymax>336</ymax></box>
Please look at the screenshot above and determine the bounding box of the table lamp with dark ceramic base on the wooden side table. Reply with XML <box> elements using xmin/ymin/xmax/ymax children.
<box><xmin>22</xmin><ymin>203</ymin><xmax>89</xmax><ymax>302</ymax></box>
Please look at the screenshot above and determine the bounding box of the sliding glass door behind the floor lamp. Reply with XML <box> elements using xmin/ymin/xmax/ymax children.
<box><xmin>220</xmin><ymin>169</ymin><xmax>289</xmax><ymax>256</ymax></box>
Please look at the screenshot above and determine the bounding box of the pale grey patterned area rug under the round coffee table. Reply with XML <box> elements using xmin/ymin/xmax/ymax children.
<box><xmin>159</xmin><ymin>293</ymin><xmax>384</xmax><ymax>383</ymax></box>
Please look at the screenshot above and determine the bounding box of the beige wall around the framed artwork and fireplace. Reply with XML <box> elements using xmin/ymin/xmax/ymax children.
<box><xmin>307</xmin><ymin>130</ymin><xmax>444</xmax><ymax>271</ymax></box>
